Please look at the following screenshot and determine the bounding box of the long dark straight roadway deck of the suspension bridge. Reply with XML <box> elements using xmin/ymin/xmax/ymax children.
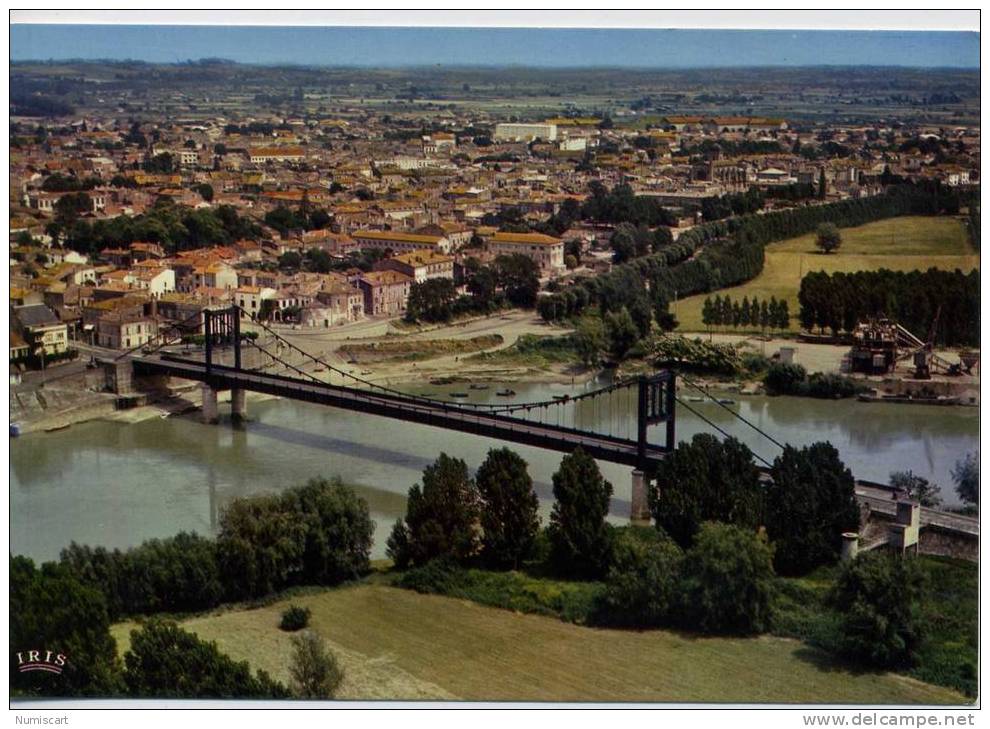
<box><xmin>133</xmin><ymin>357</ymin><xmax>666</xmax><ymax>466</ymax></box>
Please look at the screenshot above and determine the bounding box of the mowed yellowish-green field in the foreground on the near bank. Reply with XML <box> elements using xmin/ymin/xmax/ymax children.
<box><xmin>113</xmin><ymin>584</ymin><xmax>964</xmax><ymax>704</ymax></box>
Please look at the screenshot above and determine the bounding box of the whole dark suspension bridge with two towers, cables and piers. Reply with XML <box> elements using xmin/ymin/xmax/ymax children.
<box><xmin>128</xmin><ymin>306</ymin><xmax>676</xmax><ymax>521</ymax></box>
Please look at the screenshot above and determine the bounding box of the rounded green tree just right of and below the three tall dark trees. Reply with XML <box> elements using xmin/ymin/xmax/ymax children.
<box><xmin>596</xmin><ymin>527</ymin><xmax>684</xmax><ymax>628</ymax></box>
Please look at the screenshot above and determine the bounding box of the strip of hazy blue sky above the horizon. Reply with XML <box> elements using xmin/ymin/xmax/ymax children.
<box><xmin>10</xmin><ymin>24</ymin><xmax>980</xmax><ymax>68</ymax></box>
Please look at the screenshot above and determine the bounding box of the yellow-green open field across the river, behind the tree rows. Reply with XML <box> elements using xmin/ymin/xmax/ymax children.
<box><xmin>677</xmin><ymin>217</ymin><xmax>980</xmax><ymax>332</ymax></box>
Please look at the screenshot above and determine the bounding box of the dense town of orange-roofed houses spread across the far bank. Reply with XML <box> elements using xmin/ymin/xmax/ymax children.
<box><xmin>10</xmin><ymin>100</ymin><xmax>980</xmax><ymax>359</ymax></box>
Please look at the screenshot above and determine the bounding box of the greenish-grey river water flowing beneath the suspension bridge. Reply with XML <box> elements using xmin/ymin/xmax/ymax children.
<box><xmin>10</xmin><ymin>383</ymin><xmax>979</xmax><ymax>560</ymax></box>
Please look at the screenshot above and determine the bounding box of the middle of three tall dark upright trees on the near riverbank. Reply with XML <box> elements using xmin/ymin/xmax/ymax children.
<box><xmin>475</xmin><ymin>448</ymin><xmax>540</xmax><ymax>569</ymax></box>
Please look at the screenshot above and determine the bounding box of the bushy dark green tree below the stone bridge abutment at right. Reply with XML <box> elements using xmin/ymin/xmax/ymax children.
<box><xmin>831</xmin><ymin>550</ymin><xmax>924</xmax><ymax>668</ymax></box>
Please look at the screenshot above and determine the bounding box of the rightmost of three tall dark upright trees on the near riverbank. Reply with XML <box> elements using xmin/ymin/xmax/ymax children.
<box><xmin>548</xmin><ymin>448</ymin><xmax>612</xmax><ymax>578</ymax></box>
